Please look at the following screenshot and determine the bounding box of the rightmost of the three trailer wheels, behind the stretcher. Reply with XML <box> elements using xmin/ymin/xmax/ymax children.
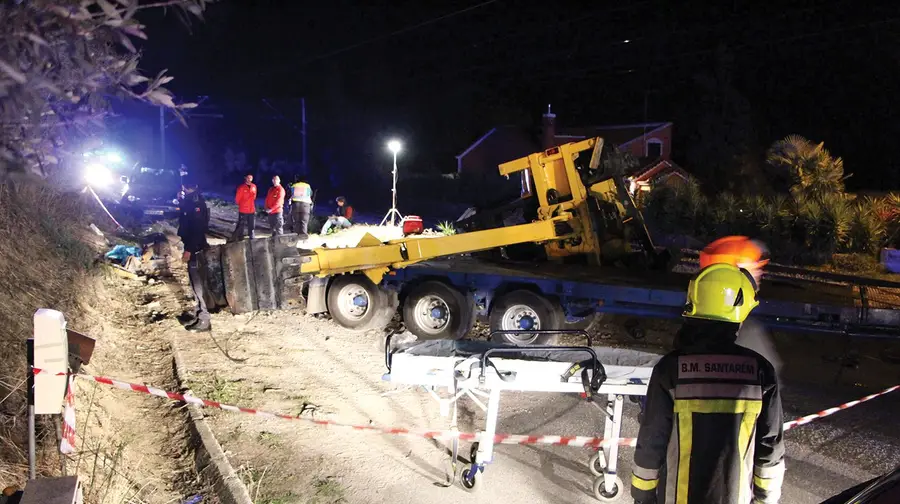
<box><xmin>491</xmin><ymin>290</ymin><xmax>562</xmax><ymax>345</ymax></box>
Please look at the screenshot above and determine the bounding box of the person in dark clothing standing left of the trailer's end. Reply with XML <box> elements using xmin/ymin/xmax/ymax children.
<box><xmin>178</xmin><ymin>179</ymin><xmax>211</xmax><ymax>332</ymax></box>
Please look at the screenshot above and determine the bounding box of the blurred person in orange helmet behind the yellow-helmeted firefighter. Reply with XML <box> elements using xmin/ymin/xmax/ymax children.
<box><xmin>696</xmin><ymin>236</ymin><xmax>782</xmax><ymax>375</ymax></box>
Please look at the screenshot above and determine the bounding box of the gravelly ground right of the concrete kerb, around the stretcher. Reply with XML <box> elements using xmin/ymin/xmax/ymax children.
<box><xmin>176</xmin><ymin>207</ymin><xmax>900</xmax><ymax>504</ymax></box>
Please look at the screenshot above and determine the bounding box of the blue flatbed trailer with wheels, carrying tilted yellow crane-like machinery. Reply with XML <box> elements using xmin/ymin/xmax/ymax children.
<box><xmin>200</xmin><ymin>137</ymin><xmax>900</xmax><ymax>344</ymax></box>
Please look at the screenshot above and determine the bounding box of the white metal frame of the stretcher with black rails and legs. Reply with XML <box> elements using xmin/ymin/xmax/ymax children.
<box><xmin>383</xmin><ymin>331</ymin><xmax>655</xmax><ymax>502</ymax></box>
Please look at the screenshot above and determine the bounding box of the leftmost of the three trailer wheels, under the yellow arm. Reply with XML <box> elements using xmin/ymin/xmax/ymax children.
<box><xmin>326</xmin><ymin>275</ymin><xmax>397</xmax><ymax>332</ymax></box>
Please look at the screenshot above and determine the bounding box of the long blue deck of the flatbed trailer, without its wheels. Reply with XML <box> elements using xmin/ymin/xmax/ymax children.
<box><xmin>384</xmin><ymin>257</ymin><xmax>900</xmax><ymax>338</ymax></box>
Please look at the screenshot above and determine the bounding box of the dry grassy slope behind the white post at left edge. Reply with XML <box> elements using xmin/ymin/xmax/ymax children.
<box><xmin>0</xmin><ymin>179</ymin><xmax>104</xmax><ymax>492</ymax></box>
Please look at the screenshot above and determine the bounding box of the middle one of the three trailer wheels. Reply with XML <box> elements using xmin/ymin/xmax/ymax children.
<box><xmin>403</xmin><ymin>281</ymin><xmax>475</xmax><ymax>340</ymax></box>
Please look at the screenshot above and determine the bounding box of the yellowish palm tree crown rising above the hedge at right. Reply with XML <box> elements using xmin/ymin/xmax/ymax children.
<box><xmin>766</xmin><ymin>135</ymin><xmax>849</xmax><ymax>201</ymax></box>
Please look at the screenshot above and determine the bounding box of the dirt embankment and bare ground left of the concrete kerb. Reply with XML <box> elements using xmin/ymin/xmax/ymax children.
<box><xmin>0</xmin><ymin>182</ymin><xmax>204</xmax><ymax>504</ymax></box>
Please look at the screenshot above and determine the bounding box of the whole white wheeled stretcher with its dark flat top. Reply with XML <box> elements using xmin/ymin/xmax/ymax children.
<box><xmin>383</xmin><ymin>331</ymin><xmax>661</xmax><ymax>502</ymax></box>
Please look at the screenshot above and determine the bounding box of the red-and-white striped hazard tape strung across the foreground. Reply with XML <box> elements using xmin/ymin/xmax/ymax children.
<box><xmin>34</xmin><ymin>368</ymin><xmax>900</xmax><ymax>448</ymax></box>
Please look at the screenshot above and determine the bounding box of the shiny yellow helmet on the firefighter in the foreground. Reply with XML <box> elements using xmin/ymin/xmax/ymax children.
<box><xmin>682</xmin><ymin>263</ymin><xmax>759</xmax><ymax>324</ymax></box>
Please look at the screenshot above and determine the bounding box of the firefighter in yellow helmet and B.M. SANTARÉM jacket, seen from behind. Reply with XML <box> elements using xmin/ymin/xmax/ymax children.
<box><xmin>631</xmin><ymin>263</ymin><xmax>784</xmax><ymax>504</ymax></box>
